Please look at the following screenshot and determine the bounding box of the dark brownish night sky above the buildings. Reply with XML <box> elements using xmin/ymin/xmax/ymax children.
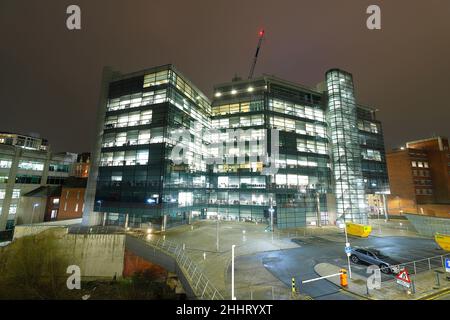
<box><xmin>0</xmin><ymin>0</ymin><xmax>450</xmax><ymax>152</ymax></box>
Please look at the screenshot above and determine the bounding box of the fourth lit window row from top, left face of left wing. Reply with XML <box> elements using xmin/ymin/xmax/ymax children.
<box><xmin>102</xmin><ymin>128</ymin><xmax>164</xmax><ymax>148</ymax></box>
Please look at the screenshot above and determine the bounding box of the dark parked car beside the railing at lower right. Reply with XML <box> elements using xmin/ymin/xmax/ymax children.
<box><xmin>350</xmin><ymin>247</ymin><xmax>400</xmax><ymax>274</ymax></box>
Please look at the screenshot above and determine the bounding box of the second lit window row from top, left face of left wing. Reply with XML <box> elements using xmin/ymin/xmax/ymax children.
<box><xmin>107</xmin><ymin>89</ymin><xmax>167</xmax><ymax>111</ymax></box>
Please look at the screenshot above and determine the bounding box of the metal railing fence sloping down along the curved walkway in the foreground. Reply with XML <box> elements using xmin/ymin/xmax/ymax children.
<box><xmin>131</xmin><ymin>234</ymin><xmax>224</xmax><ymax>300</ymax></box>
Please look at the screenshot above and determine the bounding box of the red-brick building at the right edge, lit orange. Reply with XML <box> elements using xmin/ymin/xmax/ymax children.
<box><xmin>386</xmin><ymin>137</ymin><xmax>450</xmax><ymax>217</ymax></box>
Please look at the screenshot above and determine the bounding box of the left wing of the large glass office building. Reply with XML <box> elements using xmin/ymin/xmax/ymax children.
<box><xmin>94</xmin><ymin>66</ymin><xmax>211</xmax><ymax>227</ymax></box>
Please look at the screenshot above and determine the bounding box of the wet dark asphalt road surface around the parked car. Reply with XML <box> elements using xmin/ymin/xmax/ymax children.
<box><xmin>236</xmin><ymin>237</ymin><xmax>443</xmax><ymax>300</ymax></box>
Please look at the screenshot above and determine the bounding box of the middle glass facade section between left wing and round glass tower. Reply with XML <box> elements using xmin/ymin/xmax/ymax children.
<box><xmin>208</xmin><ymin>77</ymin><xmax>331</xmax><ymax>228</ymax></box>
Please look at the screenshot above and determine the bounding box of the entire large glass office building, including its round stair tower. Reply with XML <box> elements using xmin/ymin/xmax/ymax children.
<box><xmin>89</xmin><ymin>65</ymin><xmax>387</xmax><ymax>228</ymax></box>
